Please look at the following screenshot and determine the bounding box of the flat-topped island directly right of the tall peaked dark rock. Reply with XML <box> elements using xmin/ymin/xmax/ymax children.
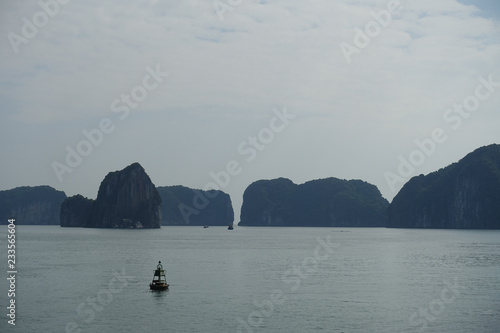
<box><xmin>158</xmin><ymin>186</ymin><xmax>234</xmax><ymax>226</ymax></box>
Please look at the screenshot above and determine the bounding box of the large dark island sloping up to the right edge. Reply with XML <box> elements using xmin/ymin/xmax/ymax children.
<box><xmin>388</xmin><ymin>145</ymin><xmax>500</xmax><ymax>229</ymax></box>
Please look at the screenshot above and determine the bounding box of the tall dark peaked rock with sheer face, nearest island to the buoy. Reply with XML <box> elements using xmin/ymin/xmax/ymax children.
<box><xmin>86</xmin><ymin>163</ymin><xmax>161</xmax><ymax>228</ymax></box>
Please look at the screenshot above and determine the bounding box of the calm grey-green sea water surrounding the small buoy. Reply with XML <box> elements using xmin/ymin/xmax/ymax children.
<box><xmin>0</xmin><ymin>226</ymin><xmax>500</xmax><ymax>333</ymax></box>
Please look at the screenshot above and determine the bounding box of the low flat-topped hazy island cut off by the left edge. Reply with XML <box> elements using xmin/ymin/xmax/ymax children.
<box><xmin>0</xmin><ymin>186</ymin><xmax>66</xmax><ymax>225</ymax></box>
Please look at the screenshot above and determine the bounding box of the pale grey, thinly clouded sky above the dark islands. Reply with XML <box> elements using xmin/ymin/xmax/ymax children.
<box><xmin>0</xmin><ymin>0</ymin><xmax>500</xmax><ymax>222</ymax></box>
